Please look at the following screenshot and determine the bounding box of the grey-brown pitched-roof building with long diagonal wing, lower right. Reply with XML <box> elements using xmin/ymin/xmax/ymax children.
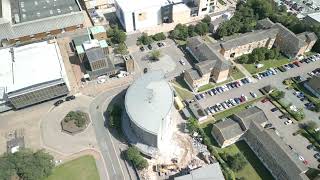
<box><xmin>211</xmin><ymin>107</ymin><xmax>308</xmax><ymax>180</ymax></box>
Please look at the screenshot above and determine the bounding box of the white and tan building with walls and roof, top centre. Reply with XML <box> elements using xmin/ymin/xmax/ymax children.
<box><xmin>115</xmin><ymin>0</ymin><xmax>217</xmax><ymax>32</ymax></box>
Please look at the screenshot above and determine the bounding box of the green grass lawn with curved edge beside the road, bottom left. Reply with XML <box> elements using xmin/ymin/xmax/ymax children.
<box><xmin>45</xmin><ymin>155</ymin><xmax>100</xmax><ymax>180</ymax></box>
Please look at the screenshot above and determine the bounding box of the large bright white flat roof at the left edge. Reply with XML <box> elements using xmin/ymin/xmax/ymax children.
<box><xmin>0</xmin><ymin>41</ymin><xmax>64</xmax><ymax>93</ymax></box>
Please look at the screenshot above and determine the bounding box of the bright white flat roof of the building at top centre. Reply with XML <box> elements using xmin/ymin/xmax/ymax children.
<box><xmin>115</xmin><ymin>0</ymin><xmax>169</xmax><ymax>11</ymax></box>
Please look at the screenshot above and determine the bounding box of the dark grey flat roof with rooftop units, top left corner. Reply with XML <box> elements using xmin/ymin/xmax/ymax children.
<box><xmin>11</xmin><ymin>0</ymin><xmax>80</xmax><ymax>24</ymax></box>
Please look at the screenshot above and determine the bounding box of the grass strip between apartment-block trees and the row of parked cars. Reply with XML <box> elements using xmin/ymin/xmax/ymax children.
<box><xmin>242</xmin><ymin>58</ymin><xmax>290</xmax><ymax>74</ymax></box>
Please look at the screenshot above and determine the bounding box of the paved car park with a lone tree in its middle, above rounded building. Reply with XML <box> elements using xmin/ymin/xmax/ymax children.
<box><xmin>131</xmin><ymin>39</ymin><xmax>192</xmax><ymax>79</ymax></box>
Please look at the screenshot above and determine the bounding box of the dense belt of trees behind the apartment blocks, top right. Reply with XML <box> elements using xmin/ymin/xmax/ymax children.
<box><xmin>217</xmin><ymin>0</ymin><xmax>320</xmax><ymax>52</ymax></box>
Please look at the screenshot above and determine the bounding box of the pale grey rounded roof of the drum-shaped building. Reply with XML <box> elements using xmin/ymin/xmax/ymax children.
<box><xmin>125</xmin><ymin>70</ymin><xmax>173</xmax><ymax>134</ymax></box>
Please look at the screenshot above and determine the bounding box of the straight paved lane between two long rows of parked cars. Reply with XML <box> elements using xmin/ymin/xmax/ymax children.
<box><xmin>199</xmin><ymin>61</ymin><xmax>320</xmax><ymax>108</ymax></box>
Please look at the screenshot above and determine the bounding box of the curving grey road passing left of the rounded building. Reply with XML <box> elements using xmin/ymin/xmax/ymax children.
<box><xmin>89</xmin><ymin>84</ymin><xmax>136</xmax><ymax>180</ymax></box>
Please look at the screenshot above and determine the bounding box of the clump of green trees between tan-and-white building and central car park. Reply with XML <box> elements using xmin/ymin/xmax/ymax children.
<box><xmin>170</xmin><ymin>16</ymin><xmax>211</xmax><ymax>41</ymax></box>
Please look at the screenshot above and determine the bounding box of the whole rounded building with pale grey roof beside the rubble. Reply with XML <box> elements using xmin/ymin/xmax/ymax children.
<box><xmin>123</xmin><ymin>71</ymin><xmax>173</xmax><ymax>154</ymax></box>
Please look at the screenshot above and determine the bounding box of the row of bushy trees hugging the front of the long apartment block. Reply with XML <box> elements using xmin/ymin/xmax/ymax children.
<box><xmin>236</xmin><ymin>47</ymin><xmax>280</xmax><ymax>64</ymax></box>
